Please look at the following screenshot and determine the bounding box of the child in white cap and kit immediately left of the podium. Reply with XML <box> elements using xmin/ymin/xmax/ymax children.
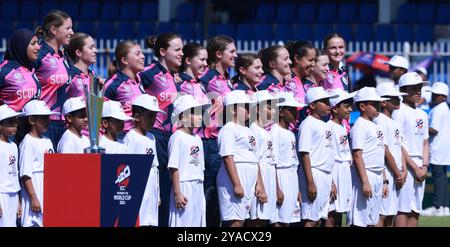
<box><xmin>19</xmin><ymin>100</ymin><xmax>60</xmax><ymax>227</ymax></box>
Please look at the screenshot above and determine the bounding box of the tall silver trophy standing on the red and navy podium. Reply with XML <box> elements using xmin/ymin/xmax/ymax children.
<box><xmin>84</xmin><ymin>74</ymin><xmax>105</xmax><ymax>153</ymax></box>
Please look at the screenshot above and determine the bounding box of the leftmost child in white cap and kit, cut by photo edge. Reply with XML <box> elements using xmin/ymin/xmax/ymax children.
<box><xmin>0</xmin><ymin>105</ymin><xmax>23</xmax><ymax>227</ymax></box>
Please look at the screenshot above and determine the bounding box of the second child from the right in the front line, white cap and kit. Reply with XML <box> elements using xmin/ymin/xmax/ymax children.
<box><xmin>374</xmin><ymin>83</ymin><xmax>406</xmax><ymax>227</ymax></box>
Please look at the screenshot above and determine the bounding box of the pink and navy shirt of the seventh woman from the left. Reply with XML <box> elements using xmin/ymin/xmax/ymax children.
<box><xmin>198</xmin><ymin>68</ymin><xmax>232</xmax><ymax>138</ymax></box>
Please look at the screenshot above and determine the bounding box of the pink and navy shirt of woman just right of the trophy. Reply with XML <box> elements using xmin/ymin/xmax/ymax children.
<box><xmin>104</xmin><ymin>71</ymin><xmax>145</xmax><ymax>132</ymax></box>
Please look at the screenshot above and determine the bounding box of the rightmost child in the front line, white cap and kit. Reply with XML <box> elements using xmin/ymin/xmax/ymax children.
<box><xmin>392</xmin><ymin>72</ymin><xmax>429</xmax><ymax>226</ymax></box>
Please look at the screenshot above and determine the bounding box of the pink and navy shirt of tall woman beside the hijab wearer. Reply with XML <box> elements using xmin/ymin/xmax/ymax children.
<box><xmin>33</xmin><ymin>41</ymin><xmax>70</xmax><ymax>120</ymax></box>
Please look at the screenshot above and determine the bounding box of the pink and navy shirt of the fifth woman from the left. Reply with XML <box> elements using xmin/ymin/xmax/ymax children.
<box><xmin>138</xmin><ymin>60</ymin><xmax>180</xmax><ymax>133</ymax></box>
